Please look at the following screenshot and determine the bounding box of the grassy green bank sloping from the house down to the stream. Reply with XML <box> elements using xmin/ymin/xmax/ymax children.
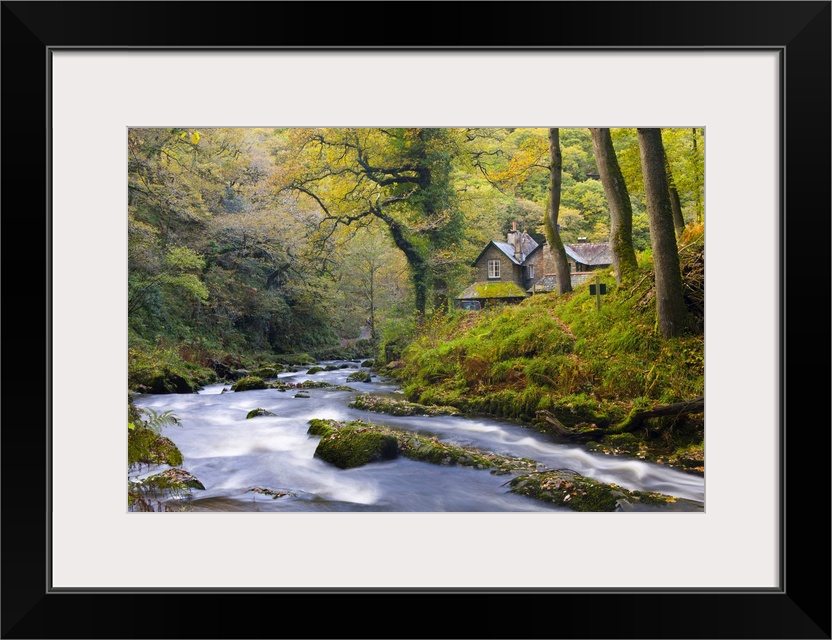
<box><xmin>393</xmin><ymin>230</ymin><xmax>704</xmax><ymax>471</ymax></box>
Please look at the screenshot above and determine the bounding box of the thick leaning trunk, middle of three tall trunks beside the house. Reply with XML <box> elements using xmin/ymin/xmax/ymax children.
<box><xmin>589</xmin><ymin>129</ymin><xmax>638</xmax><ymax>284</ymax></box>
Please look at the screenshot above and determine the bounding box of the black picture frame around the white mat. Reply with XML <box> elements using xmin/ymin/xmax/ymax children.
<box><xmin>0</xmin><ymin>1</ymin><xmax>832</xmax><ymax>638</ymax></box>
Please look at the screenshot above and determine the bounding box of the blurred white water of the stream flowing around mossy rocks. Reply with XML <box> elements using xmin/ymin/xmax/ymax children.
<box><xmin>132</xmin><ymin>361</ymin><xmax>705</xmax><ymax>512</ymax></box>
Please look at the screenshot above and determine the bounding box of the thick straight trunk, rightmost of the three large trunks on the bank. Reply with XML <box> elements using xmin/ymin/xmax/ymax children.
<box><xmin>638</xmin><ymin>129</ymin><xmax>687</xmax><ymax>338</ymax></box>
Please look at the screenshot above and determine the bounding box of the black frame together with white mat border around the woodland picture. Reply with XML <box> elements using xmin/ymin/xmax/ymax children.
<box><xmin>1</xmin><ymin>2</ymin><xmax>832</xmax><ymax>638</ymax></box>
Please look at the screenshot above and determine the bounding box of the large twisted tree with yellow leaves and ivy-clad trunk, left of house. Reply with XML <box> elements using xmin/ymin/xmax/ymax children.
<box><xmin>280</xmin><ymin>128</ymin><xmax>463</xmax><ymax>317</ymax></box>
